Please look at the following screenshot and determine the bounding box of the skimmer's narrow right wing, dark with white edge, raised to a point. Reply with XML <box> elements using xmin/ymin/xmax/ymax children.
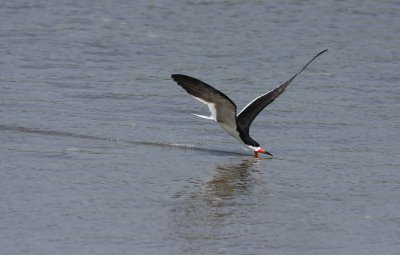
<box><xmin>237</xmin><ymin>50</ymin><xmax>327</xmax><ymax>130</ymax></box>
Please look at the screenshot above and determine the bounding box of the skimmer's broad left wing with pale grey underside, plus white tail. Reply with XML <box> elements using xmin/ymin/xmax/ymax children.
<box><xmin>171</xmin><ymin>74</ymin><xmax>236</xmax><ymax>136</ymax></box>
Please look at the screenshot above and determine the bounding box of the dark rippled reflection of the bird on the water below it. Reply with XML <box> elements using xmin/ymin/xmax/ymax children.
<box><xmin>171</xmin><ymin>159</ymin><xmax>261</xmax><ymax>247</ymax></box>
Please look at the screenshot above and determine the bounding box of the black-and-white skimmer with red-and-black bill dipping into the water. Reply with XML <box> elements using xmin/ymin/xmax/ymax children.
<box><xmin>171</xmin><ymin>50</ymin><xmax>327</xmax><ymax>157</ymax></box>
